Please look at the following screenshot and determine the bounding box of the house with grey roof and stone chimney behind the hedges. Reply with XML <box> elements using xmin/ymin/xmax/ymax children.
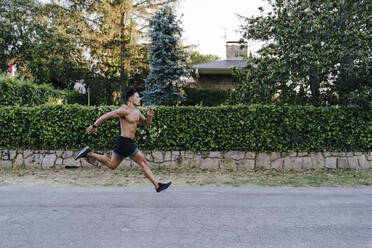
<box><xmin>193</xmin><ymin>41</ymin><xmax>248</xmax><ymax>89</ymax></box>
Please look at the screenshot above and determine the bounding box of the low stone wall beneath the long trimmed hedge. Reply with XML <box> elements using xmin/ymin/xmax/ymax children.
<box><xmin>0</xmin><ymin>150</ymin><xmax>372</xmax><ymax>170</ymax></box>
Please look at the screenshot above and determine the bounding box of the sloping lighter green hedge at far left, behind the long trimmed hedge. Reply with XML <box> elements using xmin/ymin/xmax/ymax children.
<box><xmin>0</xmin><ymin>75</ymin><xmax>80</xmax><ymax>106</ymax></box>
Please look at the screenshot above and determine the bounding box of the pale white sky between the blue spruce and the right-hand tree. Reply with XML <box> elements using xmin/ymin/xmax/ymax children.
<box><xmin>177</xmin><ymin>0</ymin><xmax>268</xmax><ymax>59</ymax></box>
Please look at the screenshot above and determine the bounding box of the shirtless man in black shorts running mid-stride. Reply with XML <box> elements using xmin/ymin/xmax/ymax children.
<box><xmin>75</xmin><ymin>89</ymin><xmax>172</xmax><ymax>192</ymax></box>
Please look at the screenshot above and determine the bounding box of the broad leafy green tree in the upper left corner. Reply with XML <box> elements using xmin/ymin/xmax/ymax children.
<box><xmin>0</xmin><ymin>0</ymin><xmax>87</xmax><ymax>88</ymax></box>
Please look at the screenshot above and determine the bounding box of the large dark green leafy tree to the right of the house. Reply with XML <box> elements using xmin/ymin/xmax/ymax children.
<box><xmin>233</xmin><ymin>0</ymin><xmax>372</xmax><ymax>106</ymax></box>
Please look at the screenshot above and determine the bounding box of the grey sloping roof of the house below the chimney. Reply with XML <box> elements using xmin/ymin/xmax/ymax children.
<box><xmin>192</xmin><ymin>60</ymin><xmax>247</xmax><ymax>74</ymax></box>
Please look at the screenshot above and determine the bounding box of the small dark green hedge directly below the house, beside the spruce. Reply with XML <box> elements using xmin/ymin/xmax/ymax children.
<box><xmin>183</xmin><ymin>87</ymin><xmax>230</xmax><ymax>106</ymax></box>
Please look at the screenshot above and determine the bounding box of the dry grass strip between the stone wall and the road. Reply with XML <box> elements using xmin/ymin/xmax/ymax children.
<box><xmin>0</xmin><ymin>168</ymin><xmax>372</xmax><ymax>187</ymax></box>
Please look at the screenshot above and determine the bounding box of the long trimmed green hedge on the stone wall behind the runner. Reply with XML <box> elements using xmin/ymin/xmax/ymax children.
<box><xmin>0</xmin><ymin>104</ymin><xmax>372</xmax><ymax>152</ymax></box>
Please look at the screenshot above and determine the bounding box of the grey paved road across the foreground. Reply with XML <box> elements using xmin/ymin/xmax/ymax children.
<box><xmin>0</xmin><ymin>185</ymin><xmax>372</xmax><ymax>248</ymax></box>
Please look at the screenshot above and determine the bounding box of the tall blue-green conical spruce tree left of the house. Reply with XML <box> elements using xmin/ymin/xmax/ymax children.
<box><xmin>142</xmin><ymin>6</ymin><xmax>188</xmax><ymax>105</ymax></box>
